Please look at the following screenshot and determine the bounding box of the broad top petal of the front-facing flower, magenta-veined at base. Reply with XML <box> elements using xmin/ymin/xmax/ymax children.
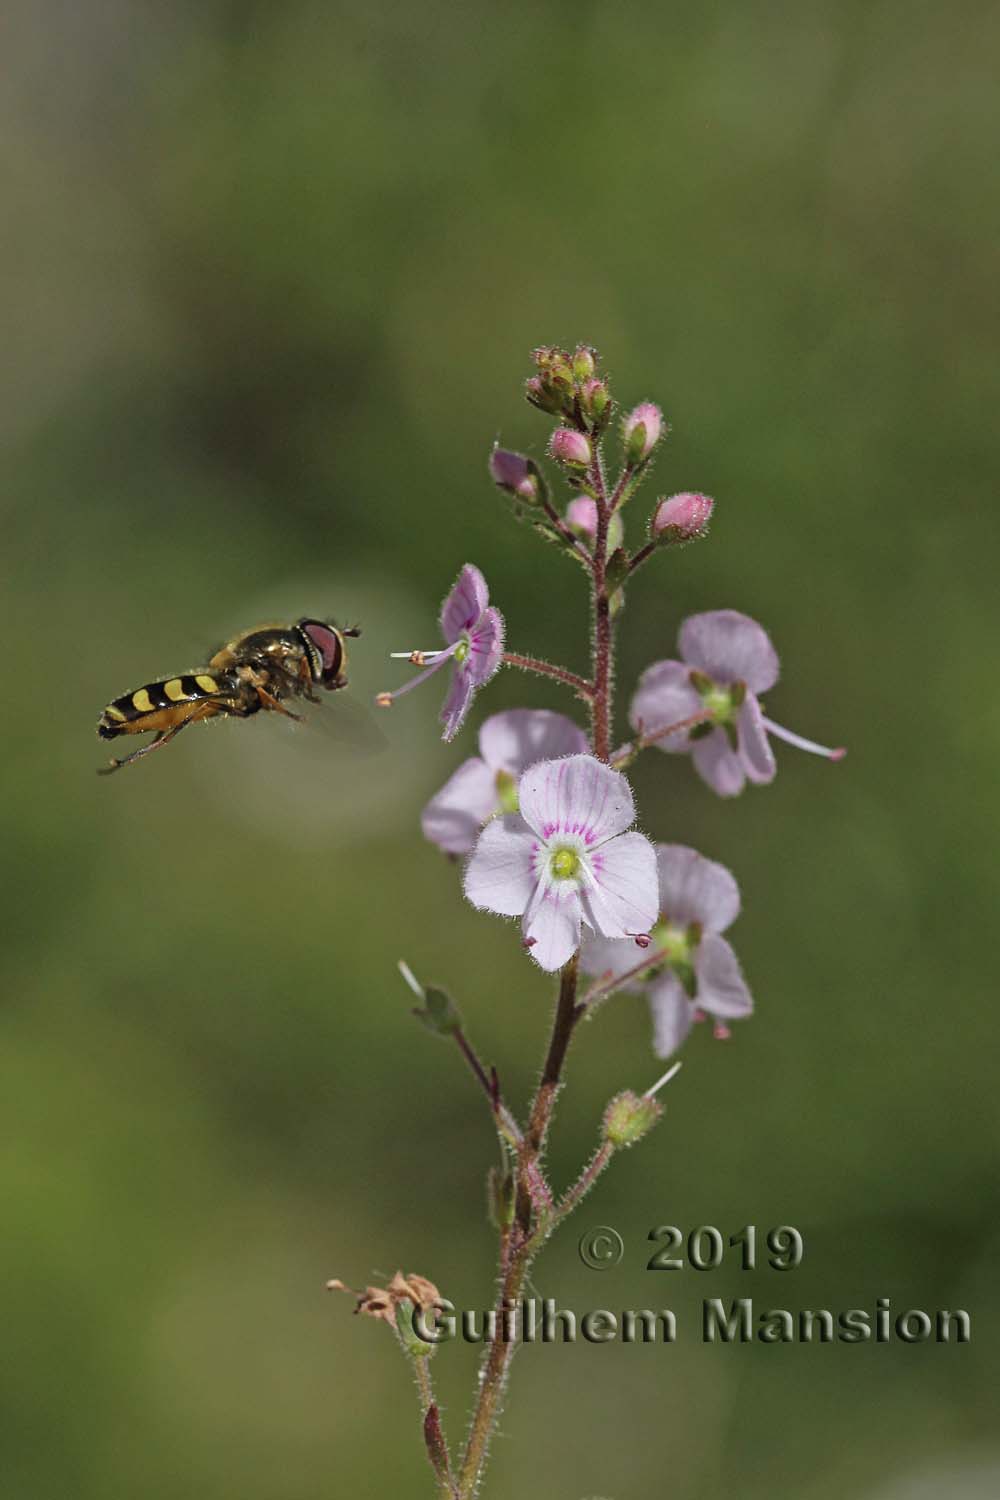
<box><xmin>517</xmin><ymin>755</ymin><xmax>636</xmax><ymax>848</ymax></box>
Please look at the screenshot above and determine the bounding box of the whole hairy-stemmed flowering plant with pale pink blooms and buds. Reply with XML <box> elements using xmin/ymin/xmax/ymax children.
<box><xmin>331</xmin><ymin>345</ymin><xmax>843</xmax><ymax>1500</ymax></box>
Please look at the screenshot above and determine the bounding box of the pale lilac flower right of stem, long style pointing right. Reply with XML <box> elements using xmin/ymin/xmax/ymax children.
<box><xmin>628</xmin><ymin>609</ymin><xmax>846</xmax><ymax>797</ymax></box>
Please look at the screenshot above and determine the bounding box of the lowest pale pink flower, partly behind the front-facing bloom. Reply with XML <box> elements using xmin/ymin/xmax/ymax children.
<box><xmin>580</xmin><ymin>845</ymin><xmax>753</xmax><ymax>1058</ymax></box>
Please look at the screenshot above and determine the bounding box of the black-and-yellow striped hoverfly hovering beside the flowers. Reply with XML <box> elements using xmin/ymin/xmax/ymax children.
<box><xmin>97</xmin><ymin>620</ymin><xmax>361</xmax><ymax>776</ymax></box>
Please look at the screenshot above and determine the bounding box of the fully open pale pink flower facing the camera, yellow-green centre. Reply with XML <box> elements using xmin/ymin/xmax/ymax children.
<box><xmin>465</xmin><ymin>755</ymin><xmax>658</xmax><ymax>971</ymax></box>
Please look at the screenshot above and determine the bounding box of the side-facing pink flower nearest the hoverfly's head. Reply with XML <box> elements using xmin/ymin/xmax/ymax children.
<box><xmin>376</xmin><ymin>563</ymin><xmax>504</xmax><ymax>740</ymax></box>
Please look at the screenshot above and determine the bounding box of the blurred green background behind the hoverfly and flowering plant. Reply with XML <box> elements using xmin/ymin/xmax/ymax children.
<box><xmin>0</xmin><ymin>0</ymin><xmax>1000</xmax><ymax>1500</ymax></box>
